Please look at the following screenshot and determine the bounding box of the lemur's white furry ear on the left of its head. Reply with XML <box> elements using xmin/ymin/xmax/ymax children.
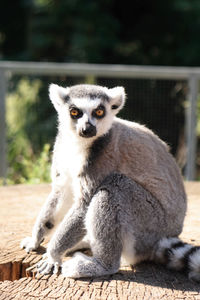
<box><xmin>49</xmin><ymin>83</ymin><xmax>69</xmax><ymax>111</ymax></box>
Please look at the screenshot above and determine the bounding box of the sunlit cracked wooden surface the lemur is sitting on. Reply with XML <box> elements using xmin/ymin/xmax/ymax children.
<box><xmin>0</xmin><ymin>182</ymin><xmax>200</xmax><ymax>300</ymax></box>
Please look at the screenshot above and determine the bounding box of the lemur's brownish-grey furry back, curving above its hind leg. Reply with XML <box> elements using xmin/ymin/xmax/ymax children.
<box><xmin>102</xmin><ymin>118</ymin><xmax>186</xmax><ymax>234</ymax></box>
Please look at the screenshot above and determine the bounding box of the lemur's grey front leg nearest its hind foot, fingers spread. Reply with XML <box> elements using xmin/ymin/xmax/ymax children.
<box><xmin>38</xmin><ymin>202</ymin><xmax>87</xmax><ymax>274</ymax></box>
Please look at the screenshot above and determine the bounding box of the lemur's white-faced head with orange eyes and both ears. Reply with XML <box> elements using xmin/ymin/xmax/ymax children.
<box><xmin>49</xmin><ymin>84</ymin><xmax>125</xmax><ymax>139</ymax></box>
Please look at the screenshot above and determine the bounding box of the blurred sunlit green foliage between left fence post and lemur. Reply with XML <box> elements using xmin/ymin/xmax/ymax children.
<box><xmin>6</xmin><ymin>78</ymin><xmax>51</xmax><ymax>184</ymax></box>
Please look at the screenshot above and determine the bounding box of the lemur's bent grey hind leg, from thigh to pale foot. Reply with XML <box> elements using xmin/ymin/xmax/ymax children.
<box><xmin>62</xmin><ymin>174</ymin><xmax>166</xmax><ymax>278</ymax></box>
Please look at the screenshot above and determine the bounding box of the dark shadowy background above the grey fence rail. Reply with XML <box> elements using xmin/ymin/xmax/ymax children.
<box><xmin>0</xmin><ymin>0</ymin><xmax>200</xmax><ymax>66</ymax></box>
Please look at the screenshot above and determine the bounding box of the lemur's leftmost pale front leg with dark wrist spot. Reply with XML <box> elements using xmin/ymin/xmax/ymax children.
<box><xmin>21</xmin><ymin>182</ymin><xmax>71</xmax><ymax>252</ymax></box>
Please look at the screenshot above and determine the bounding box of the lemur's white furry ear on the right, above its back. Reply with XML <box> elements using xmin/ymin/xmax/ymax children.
<box><xmin>108</xmin><ymin>86</ymin><xmax>126</xmax><ymax>114</ymax></box>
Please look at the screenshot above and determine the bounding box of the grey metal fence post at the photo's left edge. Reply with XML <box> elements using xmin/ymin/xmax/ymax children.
<box><xmin>0</xmin><ymin>70</ymin><xmax>6</xmax><ymax>183</ymax></box>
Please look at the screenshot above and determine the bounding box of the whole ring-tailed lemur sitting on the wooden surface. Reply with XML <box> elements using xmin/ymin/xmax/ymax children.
<box><xmin>21</xmin><ymin>84</ymin><xmax>200</xmax><ymax>280</ymax></box>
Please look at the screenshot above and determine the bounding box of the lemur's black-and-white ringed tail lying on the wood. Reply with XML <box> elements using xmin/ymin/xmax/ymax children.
<box><xmin>155</xmin><ymin>238</ymin><xmax>200</xmax><ymax>281</ymax></box>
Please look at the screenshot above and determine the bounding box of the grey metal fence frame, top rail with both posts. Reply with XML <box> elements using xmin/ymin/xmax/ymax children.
<box><xmin>0</xmin><ymin>61</ymin><xmax>200</xmax><ymax>180</ymax></box>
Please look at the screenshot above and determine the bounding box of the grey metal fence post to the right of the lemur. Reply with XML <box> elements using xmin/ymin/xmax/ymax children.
<box><xmin>185</xmin><ymin>74</ymin><xmax>198</xmax><ymax>181</ymax></box>
